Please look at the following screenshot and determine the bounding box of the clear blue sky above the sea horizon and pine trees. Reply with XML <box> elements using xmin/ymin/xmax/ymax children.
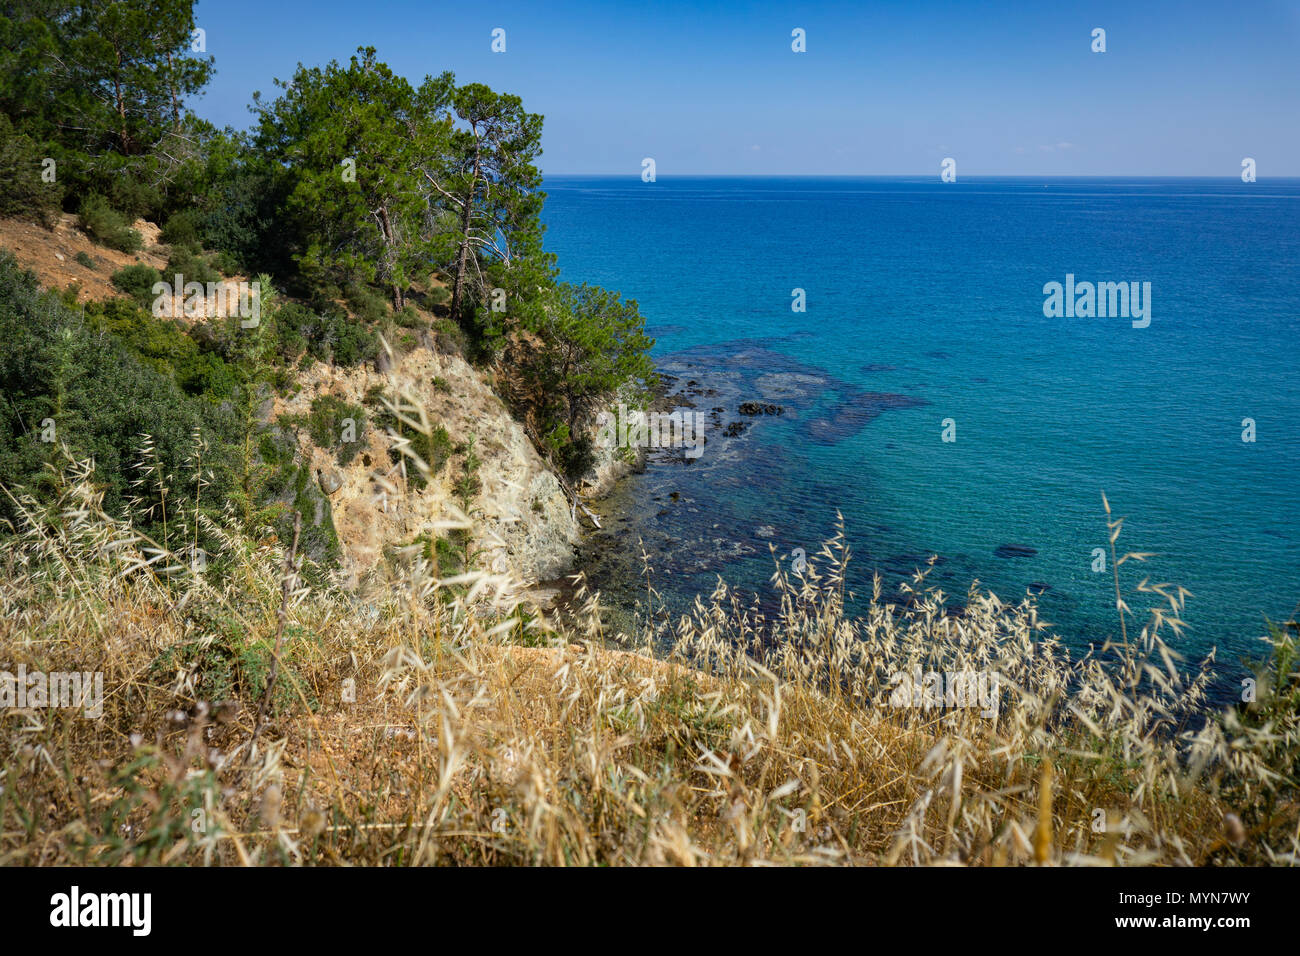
<box><xmin>192</xmin><ymin>0</ymin><xmax>1300</xmax><ymax>179</ymax></box>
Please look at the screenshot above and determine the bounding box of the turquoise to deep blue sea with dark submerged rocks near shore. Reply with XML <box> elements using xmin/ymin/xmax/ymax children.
<box><xmin>545</xmin><ymin>177</ymin><xmax>1300</xmax><ymax>661</ymax></box>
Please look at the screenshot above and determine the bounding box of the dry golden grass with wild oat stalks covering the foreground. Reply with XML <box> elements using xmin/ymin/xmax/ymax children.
<box><xmin>0</xmin><ymin>442</ymin><xmax>1300</xmax><ymax>865</ymax></box>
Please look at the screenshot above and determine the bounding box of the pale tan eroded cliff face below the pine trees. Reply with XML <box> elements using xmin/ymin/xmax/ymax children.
<box><xmin>273</xmin><ymin>347</ymin><xmax>579</xmax><ymax>585</ymax></box>
